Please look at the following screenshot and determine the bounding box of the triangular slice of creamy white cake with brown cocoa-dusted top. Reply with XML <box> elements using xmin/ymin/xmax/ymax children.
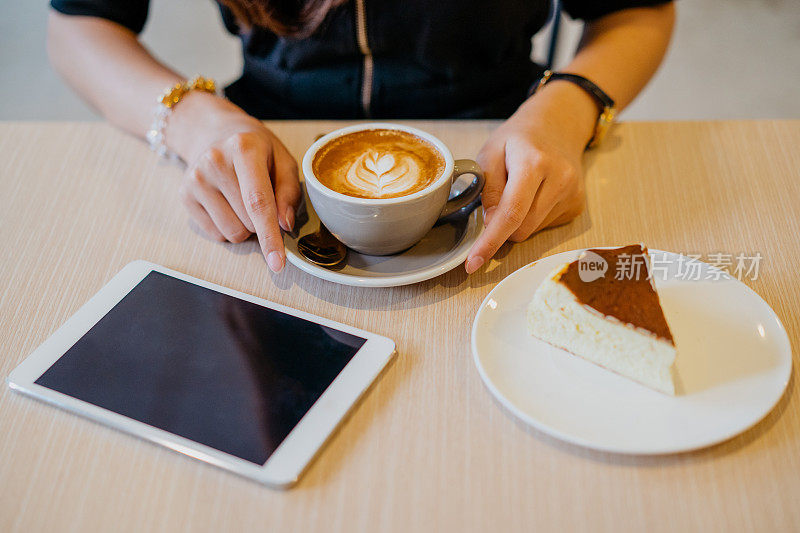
<box><xmin>527</xmin><ymin>244</ymin><xmax>676</xmax><ymax>395</ymax></box>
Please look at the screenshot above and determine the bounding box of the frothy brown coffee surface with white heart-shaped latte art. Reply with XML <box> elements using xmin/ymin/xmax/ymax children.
<box><xmin>312</xmin><ymin>129</ymin><xmax>445</xmax><ymax>198</ymax></box>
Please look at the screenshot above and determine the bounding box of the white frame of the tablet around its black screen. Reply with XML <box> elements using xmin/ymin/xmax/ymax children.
<box><xmin>6</xmin><ymin>261</ymin><xmax>395</xmax><ymax>488</ymax></box>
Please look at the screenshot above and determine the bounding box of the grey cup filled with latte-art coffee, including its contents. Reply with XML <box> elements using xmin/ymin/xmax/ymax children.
<box><xmin>303</xmin><ymin>123</ymin><xmax>484</xmax><ymax>255</ymax></box>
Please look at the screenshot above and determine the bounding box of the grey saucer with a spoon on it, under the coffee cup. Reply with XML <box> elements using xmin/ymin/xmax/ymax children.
<box><xmin>283</xmin><ymin>184</ymin><xmax>483</xmax><ymax>287</ymax></box>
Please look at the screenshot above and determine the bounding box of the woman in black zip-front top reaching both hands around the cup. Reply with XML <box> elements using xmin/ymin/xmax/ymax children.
<box><xmin>48</xmin><ymin>0</ymin><xmax>674</xmax><ymax>272</ymax></box>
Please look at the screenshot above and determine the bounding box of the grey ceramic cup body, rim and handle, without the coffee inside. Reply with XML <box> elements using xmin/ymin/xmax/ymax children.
<box><xmin>303</xmin><ymin>122</ymin><xmax>484</xmax><ymax>255</ymax></box>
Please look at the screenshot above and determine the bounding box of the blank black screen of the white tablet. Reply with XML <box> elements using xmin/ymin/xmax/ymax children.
<box><xmin>36</xmin><ymin>272</ymin><xmax>366</xmax><ymax>464</ymax></box>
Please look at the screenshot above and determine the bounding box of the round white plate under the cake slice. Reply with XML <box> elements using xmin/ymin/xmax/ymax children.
<box><xmin>472</xmin><ymin>250</ymin><xmax>792</xmax><ymax>454</ymax></box>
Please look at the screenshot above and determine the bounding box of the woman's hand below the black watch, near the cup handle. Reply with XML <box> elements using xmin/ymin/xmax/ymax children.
<box><xmin>465</xmin><ymin>81</ymin><xmax>597</xmax><ymax>273</ymax></box>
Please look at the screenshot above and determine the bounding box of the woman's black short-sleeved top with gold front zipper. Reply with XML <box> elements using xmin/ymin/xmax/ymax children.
<box><xmin>51</xmin><ymin>0</ymin><xmax>665</xmax><ymax>119</ymax></box>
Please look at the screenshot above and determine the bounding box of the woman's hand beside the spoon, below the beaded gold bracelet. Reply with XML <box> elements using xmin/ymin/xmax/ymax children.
<box><xmin>166</xmin><ymin>91</ymin><xmax>300</xmax><ymax>272</ymax></box>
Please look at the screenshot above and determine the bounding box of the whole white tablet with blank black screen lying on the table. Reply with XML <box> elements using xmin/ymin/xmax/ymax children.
<box><xmin>8</xmin><ymin>261</ymin><xmax>395</xmax><ymax>487</ymax></box>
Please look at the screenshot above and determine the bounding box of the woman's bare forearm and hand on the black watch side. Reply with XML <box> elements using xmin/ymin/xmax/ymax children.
<box><xmin>466</xmin><ymin>3</ymin><xmax>675</xmax><ymax>273</ymax></box>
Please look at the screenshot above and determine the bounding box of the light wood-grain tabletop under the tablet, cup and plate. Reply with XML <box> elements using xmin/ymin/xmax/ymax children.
<box><xmin>0</xmin><ymin>121</ymin><xmax>800</xmax><ymax>532</ymax></box>
